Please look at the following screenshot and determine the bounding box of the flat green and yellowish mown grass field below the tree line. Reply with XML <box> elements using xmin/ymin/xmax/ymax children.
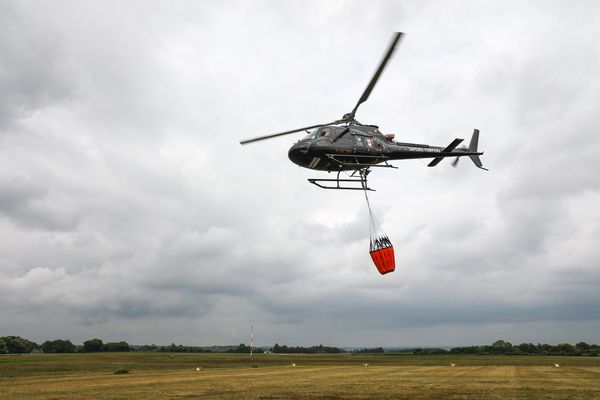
<box><xmin>0</xmin><ymin>353</ymin><xmax>600</xmax><ymax>400</ymax></box>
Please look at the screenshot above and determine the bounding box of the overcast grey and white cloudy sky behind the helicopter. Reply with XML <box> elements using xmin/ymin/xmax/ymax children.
<box><xmin>0</xmin><ymin>0</ymin><xmax>600</xmax><ymax>346</ymax></box>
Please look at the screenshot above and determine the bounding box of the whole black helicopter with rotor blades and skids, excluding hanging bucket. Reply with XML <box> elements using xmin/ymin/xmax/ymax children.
<box><xmin>240</xmin><ymin>32</ymin><xmax>487</xmax><ymax>190</ymax></box>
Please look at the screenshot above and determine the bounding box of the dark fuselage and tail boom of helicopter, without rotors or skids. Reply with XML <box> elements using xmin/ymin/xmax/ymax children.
<box><xmin>288</xmin><ymin>125</ymin><xmax>482</xmax><ymax>171</ymax></box>
